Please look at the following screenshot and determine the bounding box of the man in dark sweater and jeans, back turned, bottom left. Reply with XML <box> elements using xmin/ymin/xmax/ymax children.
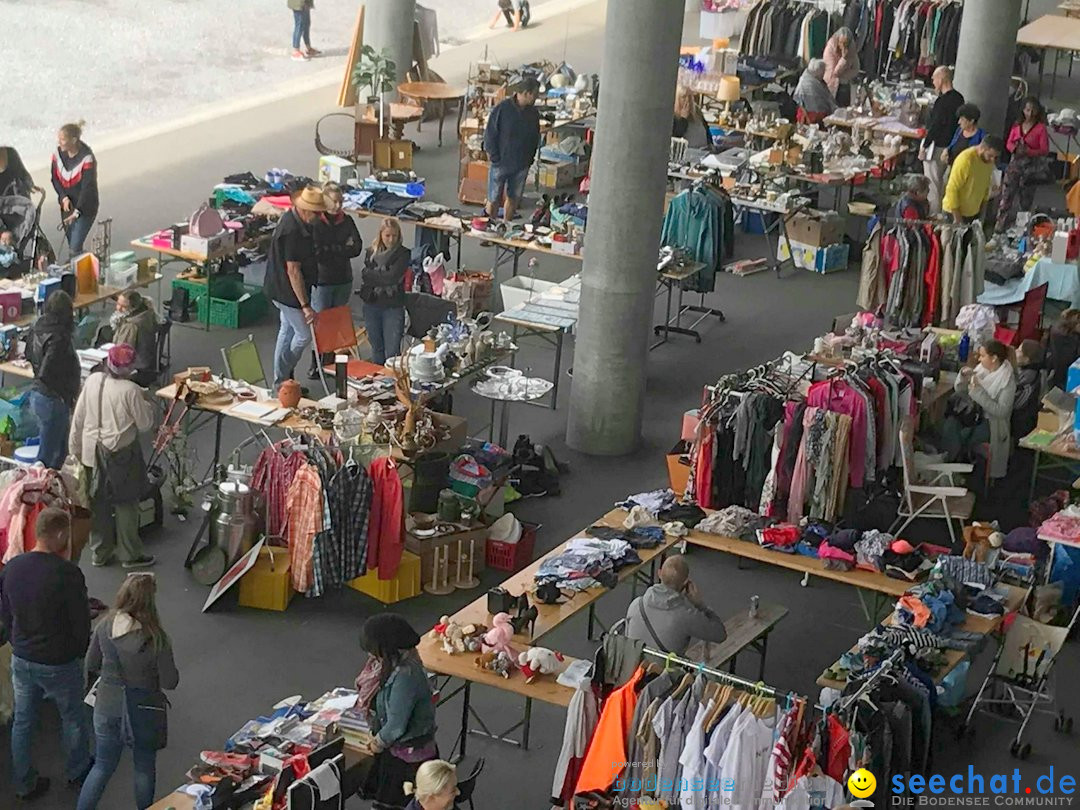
<box><xmin>0</xmin><ymin>507</ymin><xmax>93</xmax><ymax>806</ymax></box>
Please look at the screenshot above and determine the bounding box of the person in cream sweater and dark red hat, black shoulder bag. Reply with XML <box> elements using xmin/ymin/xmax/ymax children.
<box><xmin>68</xmin><ymin>345</ymin><xmax>157</xmax><ymax>568</ymax></box>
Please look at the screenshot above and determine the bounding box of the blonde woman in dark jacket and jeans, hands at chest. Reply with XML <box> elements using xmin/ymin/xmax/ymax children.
<box><xmin>359</xmin><ymin>217</ymin><xmax>411</xmax><ymax>365</ymax></box>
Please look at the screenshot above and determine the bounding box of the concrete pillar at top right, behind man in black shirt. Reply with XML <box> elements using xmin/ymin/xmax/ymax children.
<box><xmin>955</xmin><ymin>0</ymin><xmax>1023</xmax><ymax>140</ymax></box>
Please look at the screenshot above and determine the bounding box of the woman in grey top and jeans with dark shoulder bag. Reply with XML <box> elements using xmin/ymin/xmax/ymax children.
<box><xmin>77</xmin><ymin>571</ymin><xmax>180</xmax><ymax>810</ymax></box>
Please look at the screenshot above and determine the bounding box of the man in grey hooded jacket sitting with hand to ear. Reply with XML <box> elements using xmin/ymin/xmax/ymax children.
<box><xmin>626</xmin><ymin>555</ymin><xmax>728</xmax><ymax>656</ymax></box>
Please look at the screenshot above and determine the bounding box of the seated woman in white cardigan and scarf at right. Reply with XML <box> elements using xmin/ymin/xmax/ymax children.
<box><xmin>942</xmin><ymin>340</ymin><xmax>1016</xmax><ymax>478</ymax></box>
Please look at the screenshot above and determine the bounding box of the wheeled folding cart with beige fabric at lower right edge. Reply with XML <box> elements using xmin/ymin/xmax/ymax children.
<box><xmin>958</xmin><ymin>605</ymin><xmax>1080</xmax><ymax>759</ymax></box>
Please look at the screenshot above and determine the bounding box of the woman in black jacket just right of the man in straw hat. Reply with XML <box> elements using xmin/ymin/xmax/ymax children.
<box><xmin>308</xmin><ymin>183</ymin><xmax>364</xmax><ymax>380</ymax></box>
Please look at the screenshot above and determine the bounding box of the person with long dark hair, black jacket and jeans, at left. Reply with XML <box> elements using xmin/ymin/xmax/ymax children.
<box><xmin>26</xmin><ymin>289</ymin><xmax>82</xmax><ymax>470</ymax></box>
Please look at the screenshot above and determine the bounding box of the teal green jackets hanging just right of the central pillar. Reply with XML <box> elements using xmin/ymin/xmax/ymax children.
<box><xmin>660</xmin><ymin>185</ymin><xmax>734</xmax><ymax>293</ymax></box>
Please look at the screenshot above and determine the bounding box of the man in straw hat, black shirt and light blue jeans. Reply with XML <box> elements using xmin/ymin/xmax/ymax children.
<box><xmin>264</xmin><ymin>186</ymin><xmax>326</xmax><ymax>388</ymax></box>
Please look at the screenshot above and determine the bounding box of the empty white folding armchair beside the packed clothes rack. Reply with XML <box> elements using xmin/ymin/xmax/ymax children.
<box><xmin>889</xmin><ymin>419</ymin><xmax>975</xmax><ymax>546</ymax></box>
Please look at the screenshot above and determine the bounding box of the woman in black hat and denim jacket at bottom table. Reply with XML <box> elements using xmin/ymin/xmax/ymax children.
<box><xmin>359</xmin><ymin>613</ymin><xmax>438</xmax><ymax>810</ymax></box>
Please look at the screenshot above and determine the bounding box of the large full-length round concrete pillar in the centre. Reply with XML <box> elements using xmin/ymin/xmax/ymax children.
<box><xmin>567</xmin><ymin>0</ymin><xmax>683</xmax><ymax>456</ymax></box>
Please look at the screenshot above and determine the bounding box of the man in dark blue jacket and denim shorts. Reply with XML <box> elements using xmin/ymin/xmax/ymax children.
<box><xmin>484</xmin><ymin>78</ymin><xmax>540</xmax><ymax>220</ymax></box>
